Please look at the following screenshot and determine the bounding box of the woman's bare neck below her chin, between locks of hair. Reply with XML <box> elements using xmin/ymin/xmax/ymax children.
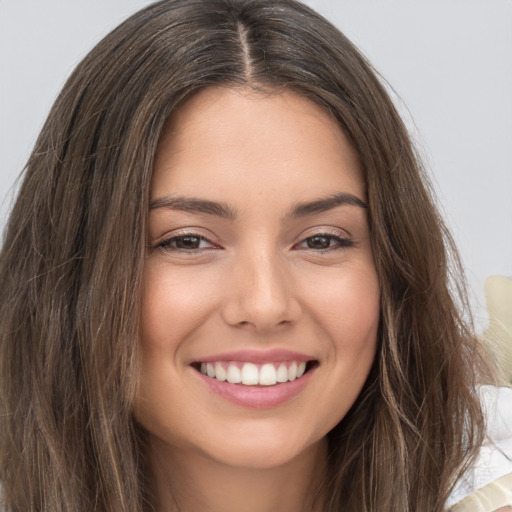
<box><xmin>150</xmin><ymin>439</ymin><xmax>327</xmax><ymax>512</ymax></box>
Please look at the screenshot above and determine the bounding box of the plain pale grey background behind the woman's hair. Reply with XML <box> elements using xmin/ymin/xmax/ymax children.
<box><xmin>0</xmin><ymin>0</ymin><xmax>512</xmax><ymax>329</ymax></box>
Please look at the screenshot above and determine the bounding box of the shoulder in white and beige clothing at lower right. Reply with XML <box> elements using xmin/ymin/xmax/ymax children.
<box><xmin>447</xmin><ymin>386</ymin><xmax>512</xmax><ymax>512</ymax></box>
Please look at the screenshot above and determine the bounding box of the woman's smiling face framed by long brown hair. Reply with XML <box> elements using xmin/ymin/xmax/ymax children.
<box><xmin>136</xmin><ymin>87</ymin><xmax>379</xmax><ymax>468</ymax></box>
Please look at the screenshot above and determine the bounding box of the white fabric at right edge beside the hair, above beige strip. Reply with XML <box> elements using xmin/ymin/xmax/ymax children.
<box><xmin>446</xmin><ymin>386</ymin><xmax>512</xmax><ymax>510</ymax></box>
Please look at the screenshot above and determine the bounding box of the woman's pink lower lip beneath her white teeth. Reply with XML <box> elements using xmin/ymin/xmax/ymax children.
<box><xmin>194</xmin><ymin>368</ymin><xmax>315</xmax><ymax>409</ymax></box>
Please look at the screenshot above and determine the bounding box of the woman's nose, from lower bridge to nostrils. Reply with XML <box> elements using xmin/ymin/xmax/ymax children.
<box><xmin>222</xmin><ymin>251</ymin><xmax>301</xmax><ymax>332</ymax></box>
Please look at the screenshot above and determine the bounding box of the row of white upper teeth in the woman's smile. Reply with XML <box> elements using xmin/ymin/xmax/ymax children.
<box><xmin>201</xmin><ymin>361</ymin><xmax>306</xmax><ymax>386</ymax></box>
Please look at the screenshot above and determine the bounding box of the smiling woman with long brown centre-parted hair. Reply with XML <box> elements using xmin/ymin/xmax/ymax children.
<box><xmin>0</xmin><ymin>0</ymin><xmax>508</xmax><ymax>512</ymax></box>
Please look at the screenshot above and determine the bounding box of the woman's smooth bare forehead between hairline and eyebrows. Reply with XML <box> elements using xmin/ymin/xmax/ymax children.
<box><xmin>152</xmin><ymin>87</ymin><xmax>366</xmax><ymax>207</ymax></box>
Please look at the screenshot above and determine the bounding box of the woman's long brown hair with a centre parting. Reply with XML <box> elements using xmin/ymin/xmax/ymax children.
<box><xmin>0</xmin><ymin>0</ymin><xmax>485</xmax><ymax>512</ymax></box>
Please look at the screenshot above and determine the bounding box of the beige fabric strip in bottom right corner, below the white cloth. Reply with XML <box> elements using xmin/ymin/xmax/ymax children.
<box><xmin>450</xmin><ymin>473</ymin><xmax>512</xmax><ymax>512</ymax></box>
